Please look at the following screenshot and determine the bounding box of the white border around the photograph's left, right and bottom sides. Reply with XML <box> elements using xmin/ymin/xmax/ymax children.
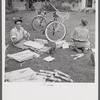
<box><xmin>2</xmin><ymin>0</ymin><xmax>98</xmax><ymax>100</ymax></box>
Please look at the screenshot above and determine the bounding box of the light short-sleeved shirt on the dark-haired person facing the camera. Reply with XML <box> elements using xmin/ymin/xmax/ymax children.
<box><xmin>10</xmin><ymin>27</ymin><xmax>27</xmax><ymax>41</ymax></box>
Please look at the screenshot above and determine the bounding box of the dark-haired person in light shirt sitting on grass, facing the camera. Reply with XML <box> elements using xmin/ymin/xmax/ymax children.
<box><xmin>10</xmin><ymin>18</ymin><xmax>30</xmax><ymax>49</ymax></box>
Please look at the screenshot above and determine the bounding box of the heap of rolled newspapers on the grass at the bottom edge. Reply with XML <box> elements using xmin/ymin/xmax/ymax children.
<box><xmin>37</xmin><ymin>69</ymin><xmax>73</xmax><ymax>83</ymax></box>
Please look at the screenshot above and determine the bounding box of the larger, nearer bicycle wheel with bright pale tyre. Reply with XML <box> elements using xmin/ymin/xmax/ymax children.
<box><xmin>45</xmin><ymin>21</ymin><xmax>66</xmax><ymax>42</ymax></box>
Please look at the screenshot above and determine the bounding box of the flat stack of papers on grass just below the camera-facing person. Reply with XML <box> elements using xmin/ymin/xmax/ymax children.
<box><xmin>7</xmin><ymin>50</ymin><xmax>40</xmax><ymax>62</ymax></box>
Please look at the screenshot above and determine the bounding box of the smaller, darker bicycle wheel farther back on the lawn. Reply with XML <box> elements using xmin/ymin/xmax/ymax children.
<box><xmin>31</xmin><ymin>16</ymin><xmax>47</xmax><ymax>31</ymax></box>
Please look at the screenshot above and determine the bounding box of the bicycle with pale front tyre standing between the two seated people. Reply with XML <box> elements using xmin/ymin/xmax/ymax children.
<box><xmin>31</xmin><ymin>4</ymin><xmax>70</xmax><ymax>42</ymax></box>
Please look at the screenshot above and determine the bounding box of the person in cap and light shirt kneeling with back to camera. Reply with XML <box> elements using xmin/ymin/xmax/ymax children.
<box><xmin>70</xmin><ymin>19</ymin><xmax>90</xmax><ymax>53</ymax></box>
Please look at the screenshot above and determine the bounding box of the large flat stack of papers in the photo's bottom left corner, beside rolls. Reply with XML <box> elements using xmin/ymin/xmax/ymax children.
<box><xmin>5</xmin><ymin>68</ymin><xmax>45</xmax><ymax>82</ymax></box>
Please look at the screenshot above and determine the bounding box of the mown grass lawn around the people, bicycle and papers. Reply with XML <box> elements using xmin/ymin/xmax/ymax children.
<box><xmin>5</xmin><ymin>11</ymin><xmax>95</xmax><ymax>82</ymax></box>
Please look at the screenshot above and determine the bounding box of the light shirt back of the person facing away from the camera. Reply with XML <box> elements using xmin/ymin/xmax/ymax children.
<box><xmin>71</xmin><ymin>26</ymin><xmax>89</xmax><ymax>41</ymax></box>
